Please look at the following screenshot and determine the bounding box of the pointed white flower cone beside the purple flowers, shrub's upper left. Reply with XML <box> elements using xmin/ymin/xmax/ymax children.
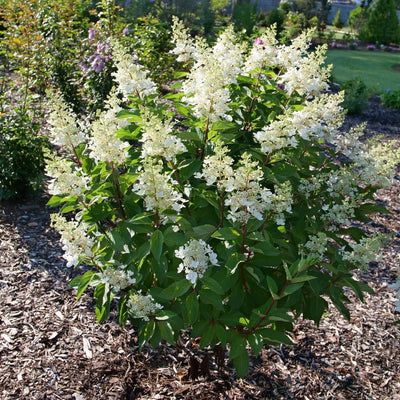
<box><xmin>113</xmin><ymin>43</ymin><xmax>157</xmax><ymax>100</ymax></box>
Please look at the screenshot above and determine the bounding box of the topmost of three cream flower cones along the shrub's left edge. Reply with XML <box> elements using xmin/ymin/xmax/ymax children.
<box><xmin>47</xmin><ymin>93</ymin><xmax>87</xmax><ymax>152</ymax></box>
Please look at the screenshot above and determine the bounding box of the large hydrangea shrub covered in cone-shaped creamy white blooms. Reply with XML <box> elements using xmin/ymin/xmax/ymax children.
<box><xmin>47</xmin><ymin>19</ymin><xmax>400</xmax><ymax>376</ymax></box>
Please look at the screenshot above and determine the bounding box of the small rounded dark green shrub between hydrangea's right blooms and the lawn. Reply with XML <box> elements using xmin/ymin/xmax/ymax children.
<box><xmin>340</xmin><ymin>77</ymin><xmax>373</xmax><ymax>114</ymax></box>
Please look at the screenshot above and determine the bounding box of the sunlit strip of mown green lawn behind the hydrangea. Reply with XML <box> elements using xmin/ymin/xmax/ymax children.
<box><xmin>327</xmin><ymin>50</ymin><xmax>400</xmax><ymax>94</ymax></box>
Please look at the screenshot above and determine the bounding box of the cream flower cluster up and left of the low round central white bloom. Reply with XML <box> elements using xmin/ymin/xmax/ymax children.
<box><xmin>132</xmin><ymin>158</ymin><xmax>187</xmax><ymax>214</ymax></box>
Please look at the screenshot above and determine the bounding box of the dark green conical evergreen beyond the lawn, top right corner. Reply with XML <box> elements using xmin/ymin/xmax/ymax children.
<box><xmin>360</xmin><ymin>0</ymin><xmax>400</xmax><ymax>44</ymax></box>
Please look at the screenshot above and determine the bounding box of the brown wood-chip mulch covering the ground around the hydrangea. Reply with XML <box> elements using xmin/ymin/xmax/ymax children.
<box><xmin>0</xmin><ymin>99</ymin><xmax>400</xmax><ymax>400</ymax></box>
